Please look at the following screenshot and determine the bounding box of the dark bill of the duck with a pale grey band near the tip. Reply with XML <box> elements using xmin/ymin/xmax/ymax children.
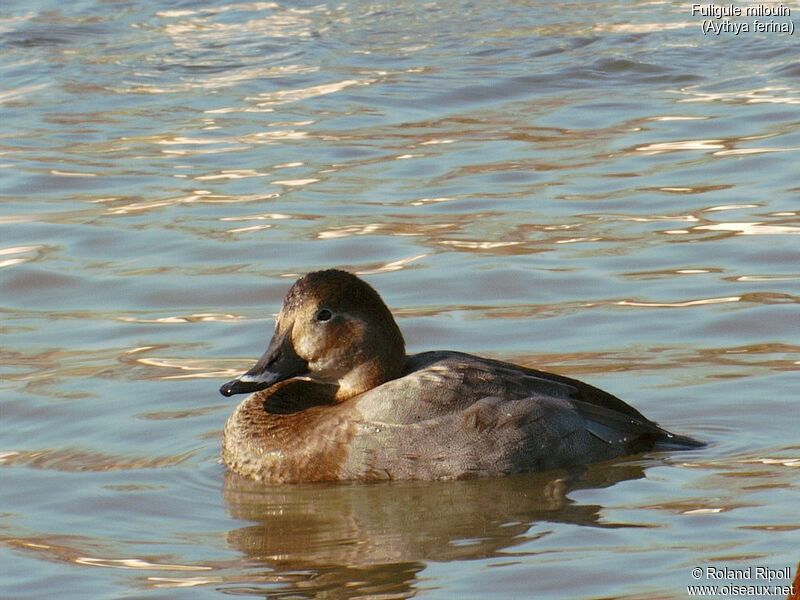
<box><xmin>219</xmin><ymin>328</ymin><xmax>308</xmax><ymax>396</ymax></box>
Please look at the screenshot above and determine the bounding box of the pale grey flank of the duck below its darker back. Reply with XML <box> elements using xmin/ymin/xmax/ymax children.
<box><xmin>350</xmin><ymin>396</ymin><xmax>658</xmax><ymax>479</ymax></box>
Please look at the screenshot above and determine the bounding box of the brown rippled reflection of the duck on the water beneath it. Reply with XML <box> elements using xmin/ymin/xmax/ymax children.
<box><xmin>223</xmin><ymin>461</ymin><xmax>644</xmax><ymax>597</ymax></box>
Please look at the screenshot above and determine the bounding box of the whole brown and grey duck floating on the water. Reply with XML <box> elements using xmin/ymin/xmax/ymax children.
<box><xmin>220</xmin><ymin>269</ymin><xmax>703</xmax><ymax>484</ymax></box>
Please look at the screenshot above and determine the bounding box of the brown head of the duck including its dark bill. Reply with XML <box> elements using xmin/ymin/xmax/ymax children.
<box><xmin>220</xmin><ymin>270</ymin><xmax>405</xmax><ymax>401</ymax></box>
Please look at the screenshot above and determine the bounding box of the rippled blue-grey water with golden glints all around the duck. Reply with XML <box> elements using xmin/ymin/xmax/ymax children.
<box><xmin>0</xmin><ymin>0</ymin><xmax>800</xmax><ymax>599</ymax></box>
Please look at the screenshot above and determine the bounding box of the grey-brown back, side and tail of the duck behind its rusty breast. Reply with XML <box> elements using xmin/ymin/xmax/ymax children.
<box><xmin>339</xmin><ymin>352</ymin><xmax>697</xmax><ymax>479</ymax></box>
